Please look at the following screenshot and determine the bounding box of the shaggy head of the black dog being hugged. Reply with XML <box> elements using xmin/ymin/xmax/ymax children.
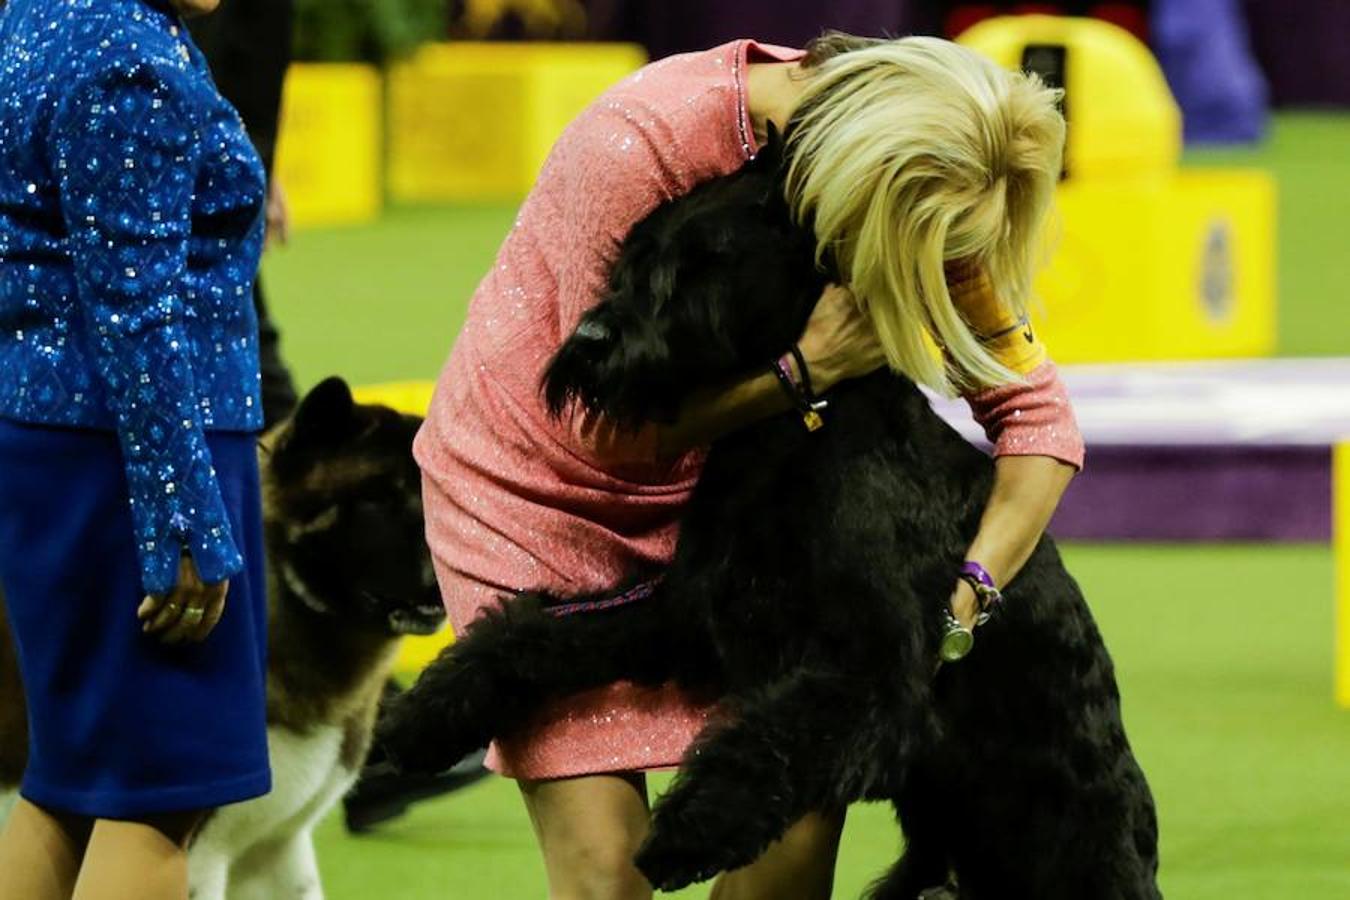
<box><xmin>543</xmin><ymin>136</ymin><xmax>826</xmax><ymax>425</ymax></box>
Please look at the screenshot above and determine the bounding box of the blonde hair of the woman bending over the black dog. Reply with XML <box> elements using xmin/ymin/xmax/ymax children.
<box><xmin>787</xmin><ymin>34</ymin><xmax>1064</xmax><ymax>393</ymax></box>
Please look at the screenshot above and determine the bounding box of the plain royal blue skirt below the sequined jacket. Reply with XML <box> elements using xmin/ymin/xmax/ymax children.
<box><xmin>0</xmin><ymin>418</ymin><xmax>271</xmax><ymax>819</ymax></box>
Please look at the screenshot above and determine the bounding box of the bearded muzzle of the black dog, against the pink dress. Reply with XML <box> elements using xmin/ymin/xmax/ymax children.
<box><xmin>543</xmin><ymin>298</ymin><xmax>674</xmax><ymax>425</ymax></box>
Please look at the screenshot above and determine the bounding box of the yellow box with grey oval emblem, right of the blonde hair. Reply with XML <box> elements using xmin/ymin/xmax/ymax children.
<box><xmin>1033</xmin><ymin>170</ymin><xmax>1276</xmax><ymax>363</ymax></box>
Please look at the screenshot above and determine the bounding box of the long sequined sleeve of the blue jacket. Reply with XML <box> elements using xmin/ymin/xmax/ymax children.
<box><xmin>50</xmin><ymin>54</ymin><xmax>243</xmax><ymax>594</ymax></box>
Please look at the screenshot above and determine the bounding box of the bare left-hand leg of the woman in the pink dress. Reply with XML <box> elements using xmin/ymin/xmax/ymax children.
<box><xmin>520</xmin><ymin>775</ymin><xmax>652</xmax><ymax>900</ymax></box>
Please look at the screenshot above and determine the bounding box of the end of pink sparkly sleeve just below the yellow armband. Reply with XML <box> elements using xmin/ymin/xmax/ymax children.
<box><xmin>965</xmin><ymin>360</ymin><xmax>1084</xmax><ymax>470</ymax></box>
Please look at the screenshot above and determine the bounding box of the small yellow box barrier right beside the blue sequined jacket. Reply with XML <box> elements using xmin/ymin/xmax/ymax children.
<box><xmin>277</xmin><ymin>63</ymin><xmax>383</xmax><ymax>228</ymax></box>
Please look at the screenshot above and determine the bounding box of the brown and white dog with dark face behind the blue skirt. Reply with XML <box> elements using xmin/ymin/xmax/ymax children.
<box><xmin>0</xmin><ymin>379</ymin><xmax>444</xmax><ymax>900</ymax></box>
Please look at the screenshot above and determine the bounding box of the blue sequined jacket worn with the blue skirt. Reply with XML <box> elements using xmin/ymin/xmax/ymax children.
<box><xmin>0</xmin><ymin>0</ymin><xmax>265</xmax><ymax>592</ymax></box>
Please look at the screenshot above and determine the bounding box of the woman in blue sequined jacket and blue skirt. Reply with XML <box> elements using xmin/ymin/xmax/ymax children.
<box><xmin>0</xmin><ymin>0</ymin><xmax>270</xmax><ymax>900</ymax></box>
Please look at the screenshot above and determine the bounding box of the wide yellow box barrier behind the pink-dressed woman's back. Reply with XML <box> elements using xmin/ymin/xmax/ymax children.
<box><xmin>389</xmin><ymin>42</ymin><xmax>645</xmax><ymax>201</ymax></box>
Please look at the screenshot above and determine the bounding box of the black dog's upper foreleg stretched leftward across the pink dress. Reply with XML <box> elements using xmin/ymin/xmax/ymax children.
<box><xmin>377</xmin><ymin>595</ymin><xmax>717</xmax><ymax>772</ymax></box>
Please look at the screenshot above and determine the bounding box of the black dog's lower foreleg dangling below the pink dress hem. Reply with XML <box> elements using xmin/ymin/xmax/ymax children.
<box><xmin>637</xmin><ymin>669</ymin><xmax>909</xmax><ymax>891</ymax></box>
